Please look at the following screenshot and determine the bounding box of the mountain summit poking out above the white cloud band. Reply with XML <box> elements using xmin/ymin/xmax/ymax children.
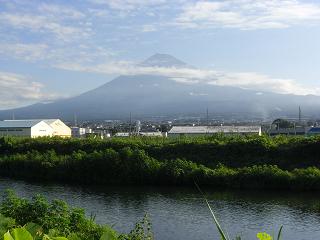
<box><xmin>139</xmin><ymin>53</ymin><xmax>190</xmax><ymax>68</ymax></box>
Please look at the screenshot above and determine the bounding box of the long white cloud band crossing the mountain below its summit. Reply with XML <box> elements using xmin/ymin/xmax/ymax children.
<box><xmin>56</xmin><ymin>61</ymin><xmax>320</xmax><ymax>95</ymax></box>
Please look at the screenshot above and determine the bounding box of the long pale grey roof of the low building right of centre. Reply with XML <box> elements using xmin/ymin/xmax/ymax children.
<box><xmin>169</xmin><ymin>126</ymin><xmax>261</xmax><ymax>134</ymax></box>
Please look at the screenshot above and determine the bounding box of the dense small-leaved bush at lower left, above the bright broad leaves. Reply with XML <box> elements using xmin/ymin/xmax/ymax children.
<box><xmin>0</xmin><ymin>191</ymin><xmax>104</xmax><ymax>239</ymax></box>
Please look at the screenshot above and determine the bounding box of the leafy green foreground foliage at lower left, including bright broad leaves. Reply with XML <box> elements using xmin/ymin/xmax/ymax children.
<box><xmin>0</xmin><ymin>191</ymin><xmax>153</xmax><ymax>240</ymax></box>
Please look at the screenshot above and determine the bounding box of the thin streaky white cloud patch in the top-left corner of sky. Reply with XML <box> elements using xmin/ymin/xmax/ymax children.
<box><xmin>0</xmin><ymin>1</ymin><xmax>92</xmax><ymax>41</ymax></box>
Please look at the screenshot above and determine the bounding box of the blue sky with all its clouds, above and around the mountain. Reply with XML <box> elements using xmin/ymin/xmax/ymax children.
<box><xmin>0</xmin><ymin>0</ymin><xmax>320</xmax><ymax>109</ymax></box>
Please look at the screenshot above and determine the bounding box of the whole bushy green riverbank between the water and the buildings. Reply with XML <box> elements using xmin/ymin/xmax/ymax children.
<box><xmin>0</xmin><ymin>135</ymin><xmax>320</xmax><ymax>190</ymax></box>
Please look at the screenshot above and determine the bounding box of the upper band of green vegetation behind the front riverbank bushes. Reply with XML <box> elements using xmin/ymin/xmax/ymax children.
<box><xmin>0</xmin><ymin>135</ymin><xmax>320</xmax><ymax>170</ymax></box>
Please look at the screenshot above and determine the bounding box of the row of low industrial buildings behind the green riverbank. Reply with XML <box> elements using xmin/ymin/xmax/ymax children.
<box><xmin>0</xmin><ymin>119</ymin><xmax>320</xmax><ymax>138</ymax></box>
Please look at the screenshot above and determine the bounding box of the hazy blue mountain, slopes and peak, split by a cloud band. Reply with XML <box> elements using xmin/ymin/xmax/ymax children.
<box><xmin>0</xmin><ymin>54</ymin><xmax>320</xmax><ymax>120</ymax></box>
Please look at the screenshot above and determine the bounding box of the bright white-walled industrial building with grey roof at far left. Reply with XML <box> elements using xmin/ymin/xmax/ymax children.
<box><xmin>0</xmin><ymin>119</ymin><xmax>71</xmax><ymax>138</ymax></box>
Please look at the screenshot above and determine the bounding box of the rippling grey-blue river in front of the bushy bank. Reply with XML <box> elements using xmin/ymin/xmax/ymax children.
<box><xmin>0</xmin><ymin>179</ymin><xmax>320</xmax><ymax>240</ymax></box>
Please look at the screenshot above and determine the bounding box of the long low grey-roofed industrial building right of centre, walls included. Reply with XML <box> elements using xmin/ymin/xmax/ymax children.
<box><xmin>168</xmin><ymin>126</ymin><xmax>261</xmax><ymax>137</ymax></box>
